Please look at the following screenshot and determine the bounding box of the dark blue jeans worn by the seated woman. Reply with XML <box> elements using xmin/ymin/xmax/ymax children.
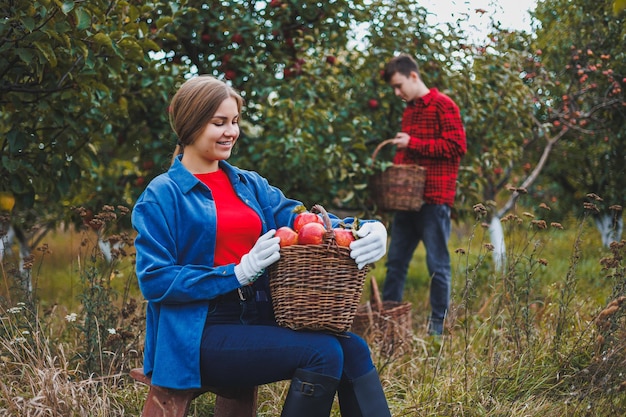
<box><xmin>200</xmin><ymin>300</ymin><xmax>374</xmax><ymax>386</ymax></box>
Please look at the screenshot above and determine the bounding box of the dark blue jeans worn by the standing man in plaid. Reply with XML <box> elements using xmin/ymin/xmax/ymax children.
<box><xmin>383</xmin><ymin>204</ymin><xmax>451</xmax><ymax>334</ymax></box>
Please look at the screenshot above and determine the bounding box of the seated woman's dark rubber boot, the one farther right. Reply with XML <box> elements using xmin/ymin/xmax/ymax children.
<box><xmin>337</xmin><ymin>369</ymin><xmax>391</xmax><ymax>417</ymax></box>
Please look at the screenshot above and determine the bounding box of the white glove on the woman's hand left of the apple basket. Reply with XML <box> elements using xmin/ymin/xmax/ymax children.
<box><xmin>235</xmin><ymin>229</ymin><xmax>280</xmax><ymax>286</ymax></box>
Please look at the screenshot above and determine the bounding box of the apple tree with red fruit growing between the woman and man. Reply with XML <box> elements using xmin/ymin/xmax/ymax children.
<box><xmin>146</xmin><ymin>0</ymin><xmax>388</xmax><ymax>206</ymax></box>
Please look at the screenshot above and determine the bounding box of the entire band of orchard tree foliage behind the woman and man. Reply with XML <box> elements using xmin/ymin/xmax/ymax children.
<box><xmin>0</xmin><ymin>0</ymin><xmax>626</xmax><ymax>234</ymax></box>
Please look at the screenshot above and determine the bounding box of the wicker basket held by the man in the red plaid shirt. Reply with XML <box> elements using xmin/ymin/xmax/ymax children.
<box><xmin>370</xmin><ymin>139</ymin><xmax>426</xmax><ymax>211</ymax></box>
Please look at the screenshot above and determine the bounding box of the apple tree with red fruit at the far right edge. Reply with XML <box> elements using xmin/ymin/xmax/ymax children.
<box><xmin>535</xmin><ymin>0</ymin><xmax>626</xmax><ymax>246</ymax></box>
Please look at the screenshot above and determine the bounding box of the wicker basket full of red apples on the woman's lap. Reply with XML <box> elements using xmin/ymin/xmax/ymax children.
<box><xmin>268</xmin><ymin>205</ymin><xmax>368</xmax><ymax>333</ymax></box>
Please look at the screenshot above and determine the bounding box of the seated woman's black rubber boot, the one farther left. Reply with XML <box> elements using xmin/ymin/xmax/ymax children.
<box><xmin>281</xmin><ymin>369</ymin><xmax>339</xmax><ymax>417</ymax></box>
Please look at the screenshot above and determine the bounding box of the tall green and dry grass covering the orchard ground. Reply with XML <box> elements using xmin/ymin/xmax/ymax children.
<box><xmin>0</xmin><ymin>201</ymin><xmax>626</xmax><ymax>417</ymax></box>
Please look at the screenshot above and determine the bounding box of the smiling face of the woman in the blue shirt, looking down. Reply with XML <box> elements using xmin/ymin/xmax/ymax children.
<box><xmin>182</xmin><ymin>97</ymin><xmax>239</xmax><ymax>174</ymax></box>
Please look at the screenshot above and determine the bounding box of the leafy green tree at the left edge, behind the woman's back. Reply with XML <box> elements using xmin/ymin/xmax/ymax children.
<box><xmin>0</xmin><ymin>0</ymin><xmax>195</xmax><ymax>280</ymax></box>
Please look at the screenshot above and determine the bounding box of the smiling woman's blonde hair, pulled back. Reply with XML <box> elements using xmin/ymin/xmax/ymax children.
<box><xmin>169</xmin><ymin>75</ymin><xmax>243</xmax><ymax>164</ymax></box>
